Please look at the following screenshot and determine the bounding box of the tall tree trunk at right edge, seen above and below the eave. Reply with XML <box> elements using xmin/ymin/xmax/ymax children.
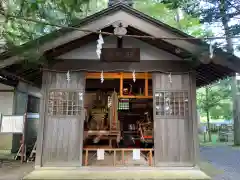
<box><xmin>220</xmin><ymin>0</ymin><xmax>240</xmax><ymax>145</ymax></box>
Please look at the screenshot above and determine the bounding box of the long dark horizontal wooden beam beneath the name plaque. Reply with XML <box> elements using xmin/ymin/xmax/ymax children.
<box><xmin>49</xmin><ymin>59</ymin><xmax>192</xmax><ymax>72</ymax></box>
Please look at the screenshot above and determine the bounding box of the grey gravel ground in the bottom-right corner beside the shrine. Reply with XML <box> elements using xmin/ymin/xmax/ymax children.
<box><xmin>200</xmin><ymin>146</ymin><xmax>240</xmax><ymax>180</ymax></box>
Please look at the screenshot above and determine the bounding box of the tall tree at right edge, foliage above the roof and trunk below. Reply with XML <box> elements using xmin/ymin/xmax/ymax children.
<box><xmin>162</xmin><ymin>0</ymin><xmax>240</xmax><ymax>145</ymax></box>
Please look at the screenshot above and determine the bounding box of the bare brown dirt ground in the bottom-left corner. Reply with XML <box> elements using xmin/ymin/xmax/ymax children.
<box><xmin>0</xmin><ymin>161</ymin><xmax>34</xmax><ymax>180</ymax></box>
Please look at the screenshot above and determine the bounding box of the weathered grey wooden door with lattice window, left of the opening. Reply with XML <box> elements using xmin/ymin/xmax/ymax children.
<box><xmin>42</xmin><ymin>72</ymin><xmax>85</xmax><ymax>167</ymax></box>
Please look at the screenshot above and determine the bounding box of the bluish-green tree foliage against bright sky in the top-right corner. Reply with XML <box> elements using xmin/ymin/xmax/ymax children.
<box><xmin>162</xmin><ymin>0</ymin><xmax>240</xmax><ymax>53</ymax></box>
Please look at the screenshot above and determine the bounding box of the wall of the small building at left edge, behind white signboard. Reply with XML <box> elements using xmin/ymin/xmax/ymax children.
<box><xmin>0</xmin><ymin>82</ymin><xmax>41</xmax><ymax>153</ymax></box>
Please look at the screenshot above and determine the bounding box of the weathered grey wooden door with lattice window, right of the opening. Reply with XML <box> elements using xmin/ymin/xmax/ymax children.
<box><xmin>153</xmin><ymin>73</ymin><xmax>194</xmax><ymax>166</ymax></box>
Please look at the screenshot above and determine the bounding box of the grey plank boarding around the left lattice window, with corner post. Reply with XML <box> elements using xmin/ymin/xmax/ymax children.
<box><xmin>36</xmin><ymin>72</ymin><xmax>85</xmax><ymax>167</ymax></box>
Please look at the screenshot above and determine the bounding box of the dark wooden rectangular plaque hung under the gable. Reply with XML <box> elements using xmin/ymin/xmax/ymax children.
<box><xmin>101</xmin><ymin>48</ymin><xmax>140</xmax><ymax>62</ymax></box>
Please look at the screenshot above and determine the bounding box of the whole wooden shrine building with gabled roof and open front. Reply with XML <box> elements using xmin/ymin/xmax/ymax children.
<box><xmin>0</xmin><ymin>0</ymin><xmax>240</xmax><ymax>179</ymax></box>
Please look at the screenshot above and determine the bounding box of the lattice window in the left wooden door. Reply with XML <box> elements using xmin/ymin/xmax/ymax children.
<box><xmin>48</xmin><ymin>91</ymin><xmax>83</xmax><ymax>115</ymax></box>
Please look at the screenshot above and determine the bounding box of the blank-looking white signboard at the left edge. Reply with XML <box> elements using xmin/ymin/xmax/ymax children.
<box><xmin>0</xmin><ymin>116</ymin><xmax>24</xmax><ymax>133</ymax></box>
